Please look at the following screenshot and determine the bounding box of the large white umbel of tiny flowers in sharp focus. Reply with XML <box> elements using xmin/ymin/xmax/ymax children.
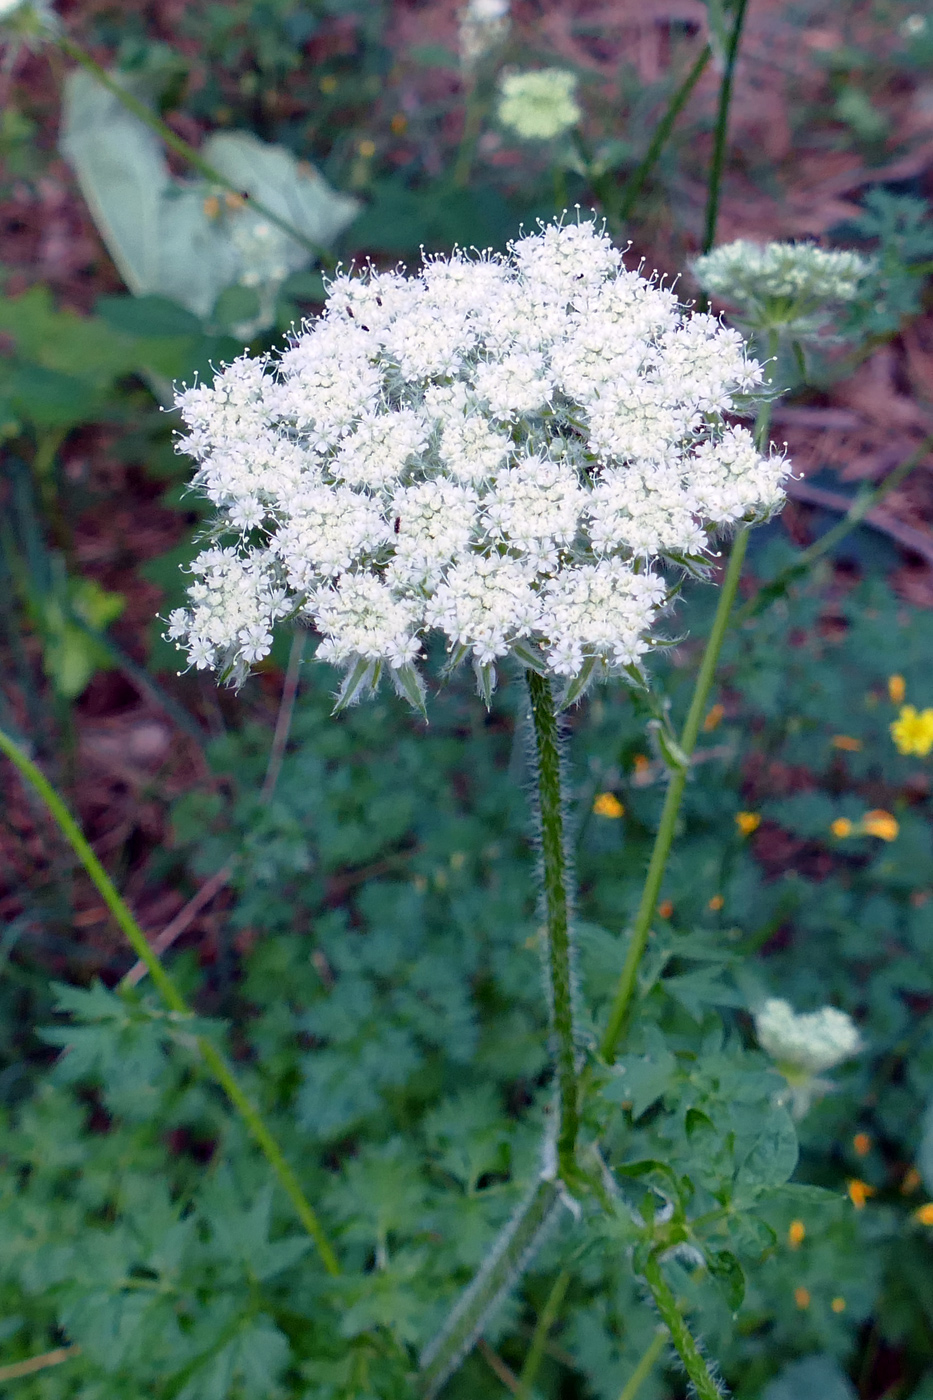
<box><xmin>168</xmin><ymin>221</ymin><xmax>787</xmax><ymax>708</ymax></box>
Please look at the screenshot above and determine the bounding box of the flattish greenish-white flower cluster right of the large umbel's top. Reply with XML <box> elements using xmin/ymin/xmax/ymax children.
<box><xmin>692</xmin><ymin>238</ymin><xmax>873</xmax><ymax>329</ymax></box>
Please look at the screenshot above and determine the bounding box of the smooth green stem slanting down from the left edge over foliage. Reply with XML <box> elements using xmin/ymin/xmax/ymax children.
<box><xmin>0</xmin><ymin>729</ymin><xmax>340</xmax><ymax>1275</ymax></box>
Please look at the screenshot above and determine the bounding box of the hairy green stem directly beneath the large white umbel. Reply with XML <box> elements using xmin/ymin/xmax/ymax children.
<box><xmin>525</xmin><ymin>671</ymin><xmax>580</xmax><ymax>1182</ymax></box>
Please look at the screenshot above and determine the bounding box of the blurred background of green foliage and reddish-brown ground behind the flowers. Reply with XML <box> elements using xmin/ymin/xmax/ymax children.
<box><xmin>0</xmin><ymin>0</ymin><xmax>933</xmax><ymax>1400</ymax></box>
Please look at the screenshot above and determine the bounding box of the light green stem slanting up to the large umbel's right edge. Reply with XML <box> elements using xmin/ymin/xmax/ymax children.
<box><xmin>600</xmin><ymin>526</ymin><xmax>748</xmax><ymax>1064</ymax></box>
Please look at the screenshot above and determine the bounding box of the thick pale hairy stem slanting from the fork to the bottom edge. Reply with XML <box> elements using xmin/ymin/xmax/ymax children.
<box><xmin>420</xmin><ymin>1179</ymin><xmax>562</xmax><ymax>1400</ymax></box>
